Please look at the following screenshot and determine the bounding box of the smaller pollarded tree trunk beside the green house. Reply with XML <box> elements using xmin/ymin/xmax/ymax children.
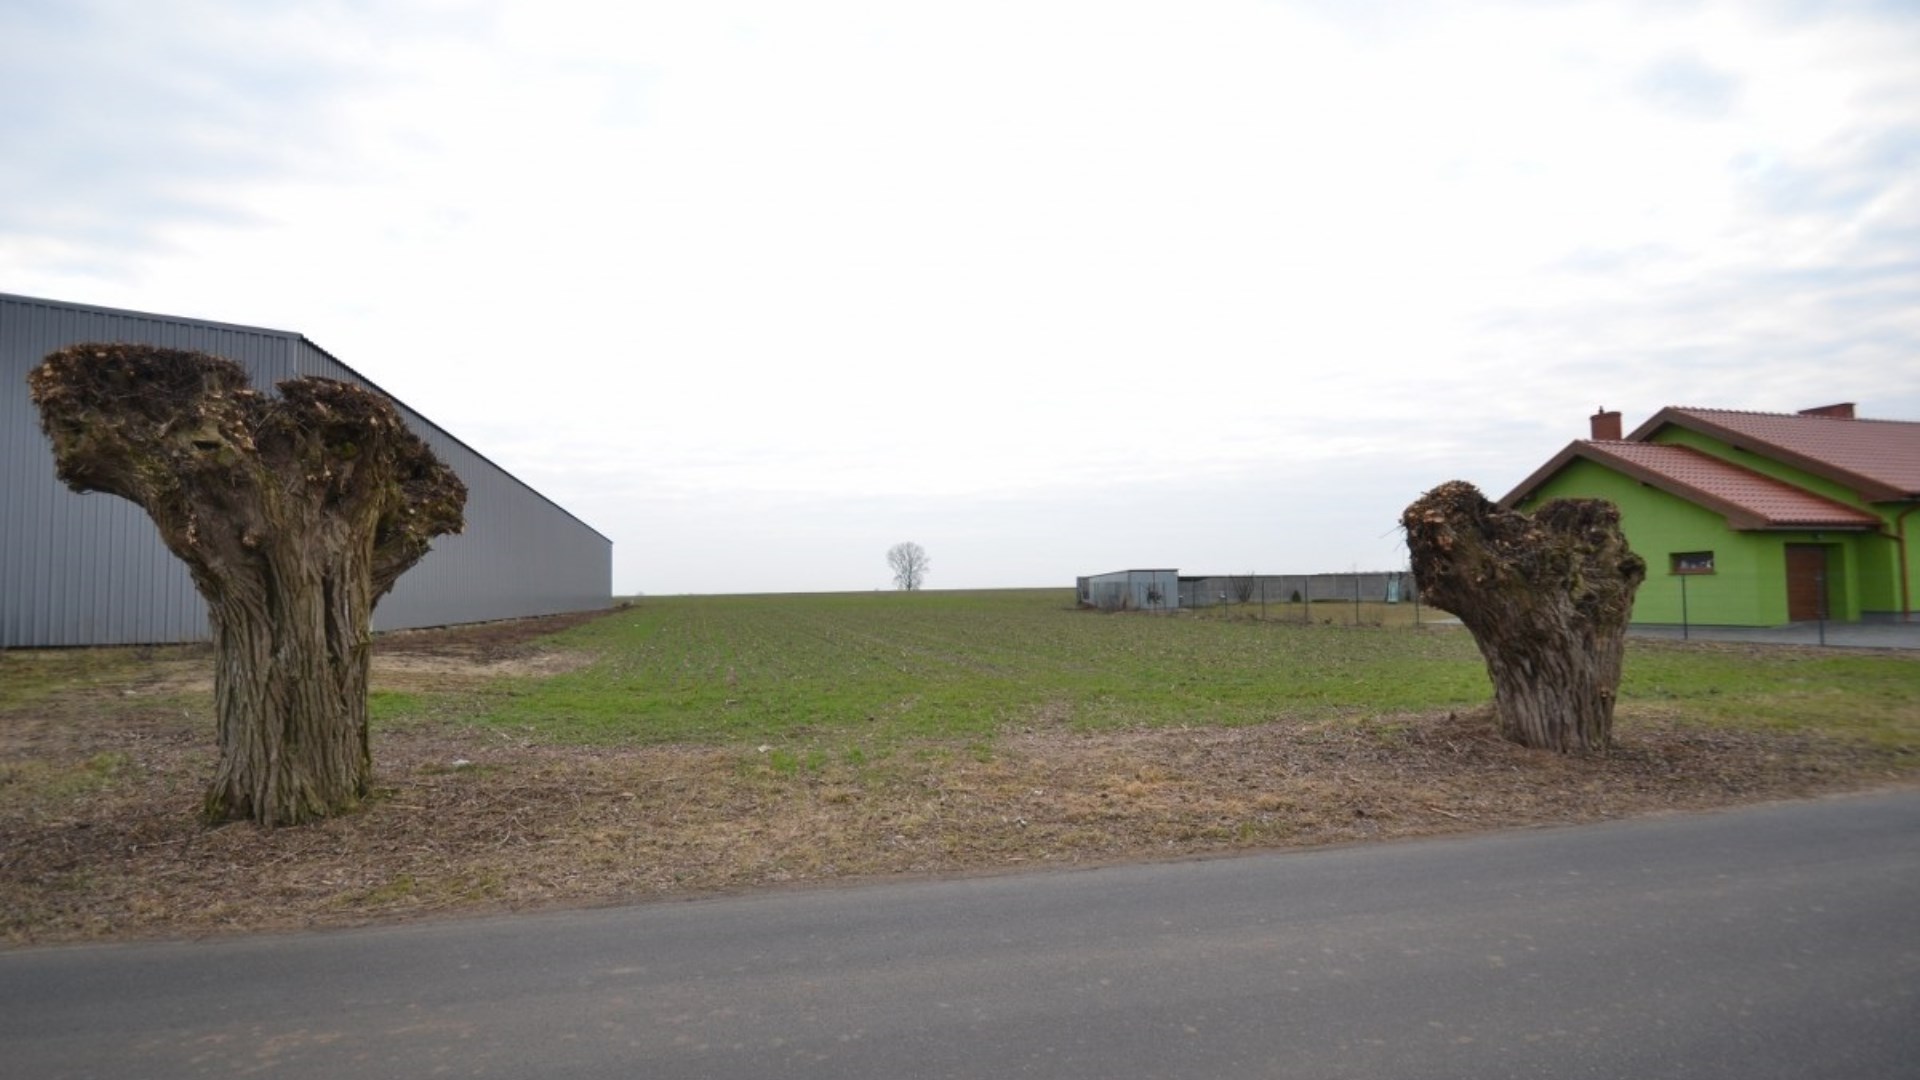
<box><xmin>1400</xmin><ymin>480</ymin><xmax>1647</xmax><ymax>753</ymax></box>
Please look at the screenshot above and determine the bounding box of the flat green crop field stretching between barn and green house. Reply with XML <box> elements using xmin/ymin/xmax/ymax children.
<box><xmin>460</xmin><ymin>590</ymin><xmax>1920</xmax><ymax>744</ymax></box>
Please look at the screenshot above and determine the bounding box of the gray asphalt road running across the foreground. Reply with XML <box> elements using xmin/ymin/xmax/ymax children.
<box><xmin>0</xmin><ymin>792</ymin><xmax>1920</xmax><ymax>1080</ymax></box>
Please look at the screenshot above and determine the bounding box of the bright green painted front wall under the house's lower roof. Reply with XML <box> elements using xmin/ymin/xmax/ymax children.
<box><xmin>1521</xmin><ymin>459</ymin><xmax>1858</xmax><ymax>626</ymax></box>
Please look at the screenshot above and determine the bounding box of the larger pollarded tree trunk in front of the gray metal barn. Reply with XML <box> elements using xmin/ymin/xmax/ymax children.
<box><xmin>27</xmin><ymin>344</ymin><xmax>467</xmax><ymax>826</ymax></box>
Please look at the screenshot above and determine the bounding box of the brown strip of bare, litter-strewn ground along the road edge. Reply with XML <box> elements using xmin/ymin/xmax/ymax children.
<box><xmin>0</xmin><ymin>617</ymin><xmax>1916</xmax><ymax>945</ymax></box>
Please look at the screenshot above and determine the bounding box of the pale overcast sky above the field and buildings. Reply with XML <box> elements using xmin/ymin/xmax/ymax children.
<box><xmin>0</xmin><ymin>0</ymin><xmax>1920</xmax><ymax>596</ymax></box>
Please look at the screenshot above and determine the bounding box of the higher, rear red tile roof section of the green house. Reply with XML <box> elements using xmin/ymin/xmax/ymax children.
<box><xmin>1626</xmin><ymin>407</ymin><xmax>1920</xmax><ymax>502</ymax></box>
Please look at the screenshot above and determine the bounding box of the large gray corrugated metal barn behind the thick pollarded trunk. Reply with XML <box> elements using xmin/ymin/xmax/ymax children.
<box><xmin>0</xmin><ymin>294</ymin><xmax>612</xmax><ymax>648</ymax></box>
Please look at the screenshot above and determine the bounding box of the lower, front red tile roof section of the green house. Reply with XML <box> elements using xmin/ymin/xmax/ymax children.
<box><xmin>1500</xmin><ymin>440</ymin><xmax>1873</xmax><ymax>528</ymax></box>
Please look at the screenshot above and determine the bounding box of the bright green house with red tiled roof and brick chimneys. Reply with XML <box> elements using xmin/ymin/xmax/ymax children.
<box><xmin>1500</xmin><ymin>404</ymin><xmax>1920</xmax><ymax>626</ymax></box>
